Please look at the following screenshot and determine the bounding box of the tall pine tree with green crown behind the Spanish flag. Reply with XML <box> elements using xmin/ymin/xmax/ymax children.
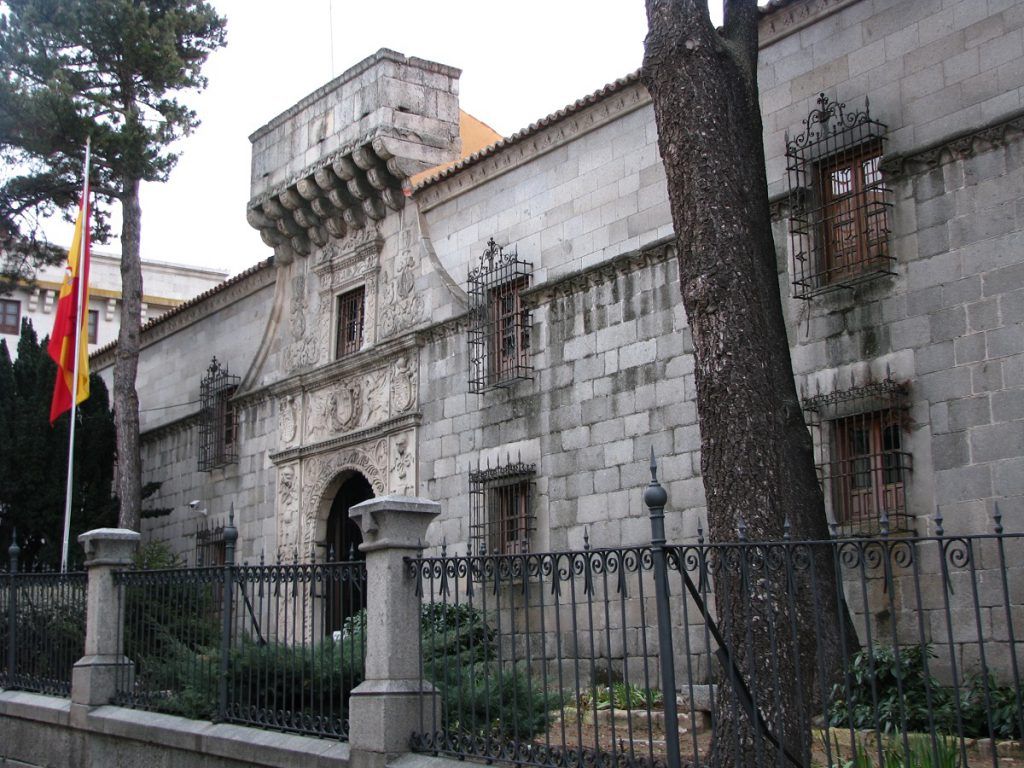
<box><xmin>0</xmin><ymin>0</ymin><xmax>224</xmax><ymax>529</ymax></box>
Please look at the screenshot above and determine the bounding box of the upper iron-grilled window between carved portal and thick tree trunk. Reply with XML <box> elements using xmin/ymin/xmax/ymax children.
<box><xmin>468</xmin><ymin>239</ymin><xmax>534</xmax><ymax>392</ymax></box>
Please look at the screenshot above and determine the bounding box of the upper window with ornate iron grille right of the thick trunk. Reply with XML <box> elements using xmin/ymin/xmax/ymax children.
<box><xmin>785</xmin><ymin>93</ymin><xmax>895</xmax><ymax>299</ymax></box>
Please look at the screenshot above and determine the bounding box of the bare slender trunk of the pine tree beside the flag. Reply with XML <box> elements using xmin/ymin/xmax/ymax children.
<box><xmin>114</xmin><ymin>179</ymin><xmax>142</xmax><ymax>530</ymax></box>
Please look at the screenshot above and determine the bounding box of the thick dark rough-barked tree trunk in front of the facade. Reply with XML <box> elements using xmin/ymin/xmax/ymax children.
<box><xmin>643</xmin><ymin>0</ymin><xmax>853</xmax><ymax>766</ymax></box>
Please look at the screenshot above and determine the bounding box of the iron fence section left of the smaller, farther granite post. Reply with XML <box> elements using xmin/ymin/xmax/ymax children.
<box><xmin>0</xmin><ymin>545</ymin><xmax>86</xmax><ymax>696</ymax></box>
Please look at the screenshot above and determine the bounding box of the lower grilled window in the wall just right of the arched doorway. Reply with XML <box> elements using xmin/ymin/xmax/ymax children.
<box><xmin>469</xmin><ymin>462</ymin><xmax>537</xmax><ymax>555</ymax></box>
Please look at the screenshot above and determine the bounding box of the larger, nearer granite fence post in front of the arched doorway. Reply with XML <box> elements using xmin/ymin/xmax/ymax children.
<box><xmin>348</xmin><ymin>496</ymin><xmax>440</xmax><ymax>768</ymax></box>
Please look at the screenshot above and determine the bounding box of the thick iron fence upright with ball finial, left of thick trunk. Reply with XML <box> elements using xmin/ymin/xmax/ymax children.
<box><xmin>643</xmin><ymin>454</ymin><xmax>680</xmax><ymax>768</ymax></box>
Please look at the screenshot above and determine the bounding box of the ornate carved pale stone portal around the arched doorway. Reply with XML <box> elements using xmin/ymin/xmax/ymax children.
<box><xmin>270</xmin><ymin>225</ymin><xmax>422</xmax><ymax>559</ymax></box>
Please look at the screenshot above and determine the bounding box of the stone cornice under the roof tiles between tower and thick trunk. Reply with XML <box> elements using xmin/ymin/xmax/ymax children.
<box><xmin>416</xmin><ymin>82</ymin><xmax>650</xmax><ymax>213</ymax></box>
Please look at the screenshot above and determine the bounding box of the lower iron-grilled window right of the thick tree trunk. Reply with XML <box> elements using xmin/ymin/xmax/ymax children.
<box><xmin>804</xmin><ymin>378</ymin><xmax>911</xmax><ymax>536</ymax></box>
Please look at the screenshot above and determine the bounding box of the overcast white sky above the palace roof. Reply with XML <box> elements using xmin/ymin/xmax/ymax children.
<box><xmin>79</xmin><ymin>0</ymin><xmax>721</xmax><ymax>273</ymax></box>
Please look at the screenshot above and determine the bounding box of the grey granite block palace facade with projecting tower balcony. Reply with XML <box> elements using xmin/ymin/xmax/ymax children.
<box><xmin>94</xmin><ymin>0</ymin><xmax>1024</xmax><ymax>589</ymax></box>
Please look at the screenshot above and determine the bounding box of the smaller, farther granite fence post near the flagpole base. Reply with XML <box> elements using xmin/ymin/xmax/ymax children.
<box><xmin>71</xmin><ymin>528</ymin><xmax>139</xmax><ymax>707</ymax></box>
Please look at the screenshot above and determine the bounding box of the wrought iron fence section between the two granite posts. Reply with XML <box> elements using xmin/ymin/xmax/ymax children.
<box><xmin>115</xmin><ymin>524</ymin><xmax>366</xmax><ymax>738</ymax></box>
